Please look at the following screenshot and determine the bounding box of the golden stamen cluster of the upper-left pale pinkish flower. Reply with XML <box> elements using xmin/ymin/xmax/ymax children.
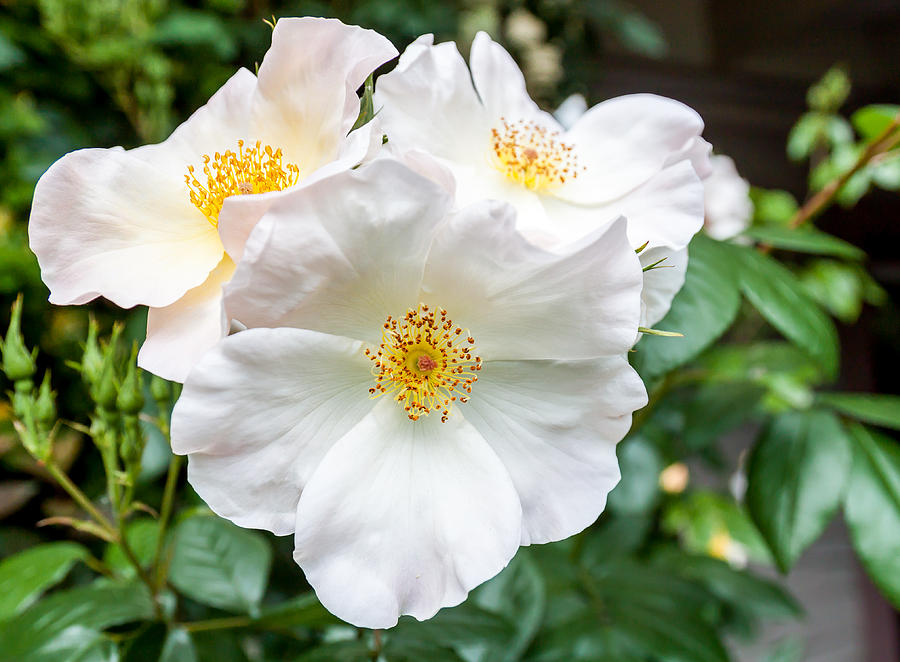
<box><xmin>184</xmin><ymin>140</ymin><xmax>300</xmax><ymax>227</ymax></box>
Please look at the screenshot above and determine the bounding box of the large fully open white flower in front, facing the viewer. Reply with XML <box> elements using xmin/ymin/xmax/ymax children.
<box><xmin>172</xmin><ymin>159</ymin><xmax>646</xmax><ymax>628</ymax></box>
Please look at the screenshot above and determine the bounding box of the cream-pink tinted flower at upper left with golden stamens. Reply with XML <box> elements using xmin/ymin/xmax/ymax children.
<box><xmin>29</xmin><ymin>18</ymin><xmax>397</xmax><ymax>381</ymax></box>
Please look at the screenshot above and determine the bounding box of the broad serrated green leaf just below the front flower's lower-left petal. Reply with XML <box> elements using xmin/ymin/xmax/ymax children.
<box><xmin>169</xmin><ymin>516</ymin><xmax>272</xmax><ymax>614</ymax></box>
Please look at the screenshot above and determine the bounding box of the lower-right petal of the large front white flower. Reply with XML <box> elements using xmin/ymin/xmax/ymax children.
<box><xmin>459</xmin><ymin>356</ymin><xmax>647</xmax><ymax>545</ymax></box>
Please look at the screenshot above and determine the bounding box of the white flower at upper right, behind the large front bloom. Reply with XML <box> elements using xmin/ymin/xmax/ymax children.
<box><xmin>375</xmin><ymin>33</ymin><xmax>709</xmax><ymax>324</ymax></box>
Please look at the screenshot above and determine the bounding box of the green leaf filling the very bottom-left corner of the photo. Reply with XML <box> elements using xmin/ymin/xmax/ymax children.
<box><xmin>0</xmin><ymin>581</ymin><xmax>154</xmax><ymax>662</ymax></box>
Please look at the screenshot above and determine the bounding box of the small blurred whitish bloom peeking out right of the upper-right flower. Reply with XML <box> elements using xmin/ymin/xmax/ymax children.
<box><xmin>703</xmin><ymin>154</ymin><xmax>753</xmax><ymax>240</ymax></box>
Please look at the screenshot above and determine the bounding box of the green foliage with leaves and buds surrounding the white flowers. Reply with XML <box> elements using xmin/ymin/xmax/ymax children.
<box><xmin>0</xmin><ymin>7</ymin><xmax>900</xmax><ymax>662</ymax></box>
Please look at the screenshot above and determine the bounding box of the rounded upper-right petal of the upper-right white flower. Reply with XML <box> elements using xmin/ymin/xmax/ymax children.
<box><xmin>557</xmin><ymin>94</ymin><xmax>703</xmax><ymax>204</ymax></box>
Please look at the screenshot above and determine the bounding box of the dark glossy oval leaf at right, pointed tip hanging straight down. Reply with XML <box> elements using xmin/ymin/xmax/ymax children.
<box><xmin>746</xmin><ymin>410</ymin><xmax>851</xmax><ymax>572</ymax></box>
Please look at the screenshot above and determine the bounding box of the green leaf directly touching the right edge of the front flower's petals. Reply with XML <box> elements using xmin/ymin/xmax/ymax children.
<box><xmin>631</xmin><ymin>235</ymin><xmax>740</xmax><ymax>381</ymax></box>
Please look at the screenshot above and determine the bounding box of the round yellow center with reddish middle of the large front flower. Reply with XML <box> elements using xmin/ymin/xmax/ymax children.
<box><xmin>366</xmin><ymin>304</ymin><xmax>481</xmax><ymax>422</ymax></box>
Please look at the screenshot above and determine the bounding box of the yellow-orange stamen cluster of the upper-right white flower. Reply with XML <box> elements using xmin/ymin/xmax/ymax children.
<box><xmin>491</xmin><ymin>117</ymin><xmax>584</xmax><ymax>191</ymax></box>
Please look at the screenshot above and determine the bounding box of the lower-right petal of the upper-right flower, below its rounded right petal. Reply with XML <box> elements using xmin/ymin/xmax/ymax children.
<box><xmin>595</xmin><ymin>160</ymin><xmax>703</xmax><ymax>249</ymax></box>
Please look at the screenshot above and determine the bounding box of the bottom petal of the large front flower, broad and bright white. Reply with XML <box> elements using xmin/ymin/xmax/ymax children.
<box><xmin>294</xmin><ymin>400</ymin><xmax>522</xmax><ymax>628</ymax></box>
